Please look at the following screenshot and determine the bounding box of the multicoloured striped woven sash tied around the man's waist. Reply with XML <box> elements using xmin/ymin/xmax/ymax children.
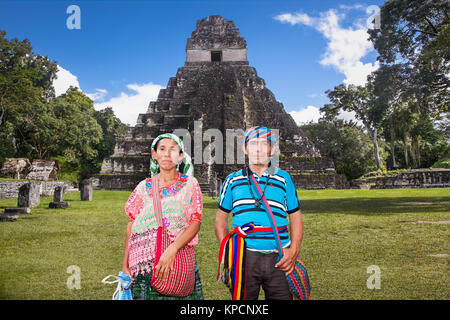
<box><xmin>217</xmin><ymin>223</ymin><xmax>287</xmax><ymax>300</ymax></box>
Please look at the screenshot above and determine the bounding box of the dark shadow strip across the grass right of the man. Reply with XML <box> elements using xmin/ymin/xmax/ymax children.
<box><xmin>300</xmin><ymin>197</ymin><xmax>450</xmax><ymax>215</ymax></box>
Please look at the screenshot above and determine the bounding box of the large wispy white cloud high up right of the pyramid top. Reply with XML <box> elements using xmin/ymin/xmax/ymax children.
<box><xmin>274</xmin><ymin>9</ymin><xmax>379</xmax><ymax>85</ymax></box>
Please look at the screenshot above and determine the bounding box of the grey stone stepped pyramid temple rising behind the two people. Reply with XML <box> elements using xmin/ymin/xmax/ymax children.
<box><xmin>93</xmin><ymin>16</ymin><xmax>346</xmax><ymax>195</ymax></box>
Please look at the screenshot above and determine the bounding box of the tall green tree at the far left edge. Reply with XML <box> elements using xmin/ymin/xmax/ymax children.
<box><xmin>0</xmin><ymin>30</ymin><xmax>57</xmax><ymax>162</ymax></box>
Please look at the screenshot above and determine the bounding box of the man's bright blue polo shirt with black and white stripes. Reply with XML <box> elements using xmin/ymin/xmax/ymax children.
<box><xmin>218</xmin><ymin>167</ymin><xmax>300</xmax><ymax>252</ymax></box>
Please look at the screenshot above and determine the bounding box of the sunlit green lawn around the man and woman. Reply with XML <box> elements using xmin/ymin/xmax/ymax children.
<box><xmin>0</xmin><ymin>188</ymin><xmax>450</xmax><ymax>300</ymax></box>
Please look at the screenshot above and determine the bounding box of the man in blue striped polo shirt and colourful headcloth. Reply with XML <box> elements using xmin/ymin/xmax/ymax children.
<box><xmin>215</xmin><ymin>126</ymin><xmax>303</xmax><ymax>300</ymax></box>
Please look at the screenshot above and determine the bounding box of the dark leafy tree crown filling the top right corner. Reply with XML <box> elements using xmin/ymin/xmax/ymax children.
<box><xmin>368</xmin><ymin>0</ymin><xmax>450</xmax><ymax>117</ymax></box>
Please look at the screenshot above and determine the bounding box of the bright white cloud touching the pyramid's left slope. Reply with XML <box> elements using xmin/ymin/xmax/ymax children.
<box><xmin>93</xmin><ymin>82</ymin><xmax>164</xmax><ymax>126</ymax></box>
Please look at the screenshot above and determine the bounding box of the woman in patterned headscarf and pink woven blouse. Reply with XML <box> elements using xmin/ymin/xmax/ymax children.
<box><xmin>122</xmin><ymin>133</ymin><xmax>203</xmax><ymax>300</ymax></box>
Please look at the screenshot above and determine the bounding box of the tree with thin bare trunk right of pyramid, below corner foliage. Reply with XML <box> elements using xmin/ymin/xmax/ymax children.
<box><xmin>367</xmin><ymin>64</ymin><xmax>446</xmax><ymax>169</ymax></box>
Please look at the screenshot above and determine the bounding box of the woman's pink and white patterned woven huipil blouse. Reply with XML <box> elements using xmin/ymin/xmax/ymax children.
<box><xmin>125</xmin><ymin>173</ymin><xmax>203</xmax><ymax>277</ymax></box>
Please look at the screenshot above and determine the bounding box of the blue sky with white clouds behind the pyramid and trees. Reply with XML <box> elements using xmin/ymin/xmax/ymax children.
<box><xmin>0</xmin><ymin>0</ymin><xmax>384</xmax><ymax>125</ymax></box>
